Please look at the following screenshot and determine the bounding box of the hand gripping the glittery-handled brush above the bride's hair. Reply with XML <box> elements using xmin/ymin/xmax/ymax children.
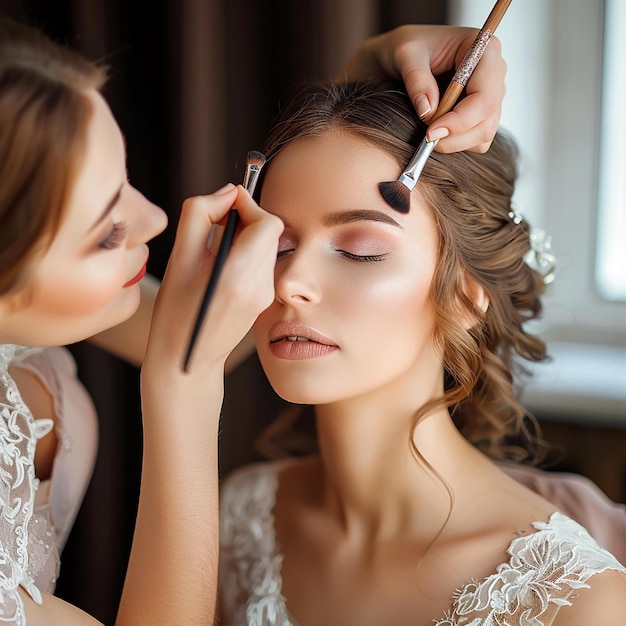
<box><xmin>341</xmin><ymin>25</ymin><xmax>506</xmax><ymax>152</ymax></box>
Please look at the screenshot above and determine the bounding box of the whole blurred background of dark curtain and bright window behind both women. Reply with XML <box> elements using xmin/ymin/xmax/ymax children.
<box><xmin>0</xmin><ymin>0</ymin><xmax>626</xmax><ymax>624</ymax></box>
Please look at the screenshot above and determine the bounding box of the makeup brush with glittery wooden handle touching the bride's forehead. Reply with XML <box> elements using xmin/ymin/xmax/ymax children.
<box><xmin>378</xmin><ymin>0</ymin><xmax>511</xmax><ymax>213</ymax></box>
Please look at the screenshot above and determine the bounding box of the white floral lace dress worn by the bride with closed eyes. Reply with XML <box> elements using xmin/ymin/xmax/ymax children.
<box><xmin>220</xmin><ymin>460</ymin><xmax>626</xmax><ymax>626</ymax></box>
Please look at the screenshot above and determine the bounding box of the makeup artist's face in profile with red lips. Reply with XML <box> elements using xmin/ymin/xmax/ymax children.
<box><xmin>0</xmin><ymin>91</ymin><xmax>167</xmax><ymax>345</ymax></box>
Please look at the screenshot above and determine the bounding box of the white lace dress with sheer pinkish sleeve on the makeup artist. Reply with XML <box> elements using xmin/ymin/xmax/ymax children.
<box><xmin>0</xmin><ymin>344</ymin><xmax>98</xmax><ymax>626</ymax></box>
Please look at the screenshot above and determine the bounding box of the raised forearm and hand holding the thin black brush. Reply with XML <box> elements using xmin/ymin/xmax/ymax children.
<box><xmin>116</xmin><ymin>187</ymin><xmax>282</xmax><ymax>626</ymax></box>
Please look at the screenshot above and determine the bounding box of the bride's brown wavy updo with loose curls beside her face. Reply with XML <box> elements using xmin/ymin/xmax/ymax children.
<box><xmin>262</xmin><ymin>83</ymin><xmax>546</xmax><ymax>458</ymax></box>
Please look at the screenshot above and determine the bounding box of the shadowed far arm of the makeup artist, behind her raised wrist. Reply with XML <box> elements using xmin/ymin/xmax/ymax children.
<box><xmin>89</xmin><ymin>245</ymin><xmax>254</xmax><ymax>374</ymax></box>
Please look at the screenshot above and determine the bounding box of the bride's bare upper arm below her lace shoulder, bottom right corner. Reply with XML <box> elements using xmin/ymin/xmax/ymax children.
<box><xmin>552</xmin><ymin>569</ymin><xmax>626</xmax><ymax>626</ymax></box>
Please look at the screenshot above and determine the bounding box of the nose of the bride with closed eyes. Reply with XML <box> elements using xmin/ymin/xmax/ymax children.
<box><xmin>274</xmin><ymin>250</ymin><xmax>321</xmax><ymax>306</ymax></box>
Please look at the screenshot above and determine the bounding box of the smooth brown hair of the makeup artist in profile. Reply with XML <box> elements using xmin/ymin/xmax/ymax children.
<box><xmin>0</xmin><ymin>18</ymin><xmax>106</xmax><ymax>294</ymax></box>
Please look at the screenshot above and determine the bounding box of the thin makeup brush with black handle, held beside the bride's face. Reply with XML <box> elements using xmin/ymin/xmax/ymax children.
<box><xmin>183</xmin><ymin>150</ymin><xmax>265</xmax><ymax>372</ymax></box>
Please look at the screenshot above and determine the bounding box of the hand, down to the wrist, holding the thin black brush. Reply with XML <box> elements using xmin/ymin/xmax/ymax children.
<box><xmin>144</xmin><ymin>185</ymin><xmax>283</xmax><ymax>380</ymax></box>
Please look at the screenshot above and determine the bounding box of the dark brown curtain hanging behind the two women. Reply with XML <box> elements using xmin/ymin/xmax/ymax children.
<box><xmin>0</xmin><ymin>0</ymin><xmax>446</xmax><ymax>624</ymax></box>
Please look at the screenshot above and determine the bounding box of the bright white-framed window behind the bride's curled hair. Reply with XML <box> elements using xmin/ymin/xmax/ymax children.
<box><xmin>450</xmin><ymin>0</ymin><xmax>626</xmax><ymax>347</ymax></box>
